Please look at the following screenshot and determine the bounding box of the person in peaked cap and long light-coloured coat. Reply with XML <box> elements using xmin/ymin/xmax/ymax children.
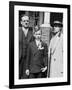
<box><xmin>48</xmin><ymin>21</ymin><xmax>63</xmax><ymax>77</ymax></box>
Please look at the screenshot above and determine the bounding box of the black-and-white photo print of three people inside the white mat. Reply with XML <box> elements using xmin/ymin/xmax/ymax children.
<box><xmin>19</xmin><ymin>11</ymin><xmax>63</xmax><ymax>79</ymax></box>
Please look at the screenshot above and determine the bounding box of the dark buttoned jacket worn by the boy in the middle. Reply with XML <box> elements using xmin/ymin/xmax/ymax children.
<box><xmin>26</xmin><ymin>41</ymin><xmax>48</xmax><ymax>73</ymax></box>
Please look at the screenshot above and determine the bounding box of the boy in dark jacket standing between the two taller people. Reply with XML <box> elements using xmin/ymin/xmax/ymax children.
<box><xmin>26</xmin><ymin>26</ymin><xmax>48</xmax><ymax>78</ymax></box>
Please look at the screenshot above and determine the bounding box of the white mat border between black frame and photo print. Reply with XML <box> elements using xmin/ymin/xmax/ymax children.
<box><xmin>14</xmin><ymin>6</ymin><xmax>67</xmax><ymax>85</ymax></box>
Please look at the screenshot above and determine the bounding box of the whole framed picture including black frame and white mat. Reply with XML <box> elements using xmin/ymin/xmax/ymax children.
<box><xmin>10</xmin><ymin>2</ymin><xmax>70</xmax><ymax>88</ymax></box>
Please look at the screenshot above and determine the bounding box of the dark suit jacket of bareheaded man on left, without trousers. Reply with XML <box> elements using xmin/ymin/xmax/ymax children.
<box><xmin>19</xmin><ymin>27</ymin><xmax>33</xmax><ymax>60</ymax></box>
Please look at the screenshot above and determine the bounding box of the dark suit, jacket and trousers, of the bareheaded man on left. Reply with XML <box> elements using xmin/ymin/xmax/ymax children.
<box><xmin>19</xmin><ymin>27</ymin><xmax>33</xmax><ymax>78</ymax></box>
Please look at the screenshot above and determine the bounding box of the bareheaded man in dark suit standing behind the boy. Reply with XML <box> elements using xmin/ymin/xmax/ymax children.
<box><xmin>19</xmin><ymin>15</ymin><xmax>33</xmax><ymax>79</ymax></box>
